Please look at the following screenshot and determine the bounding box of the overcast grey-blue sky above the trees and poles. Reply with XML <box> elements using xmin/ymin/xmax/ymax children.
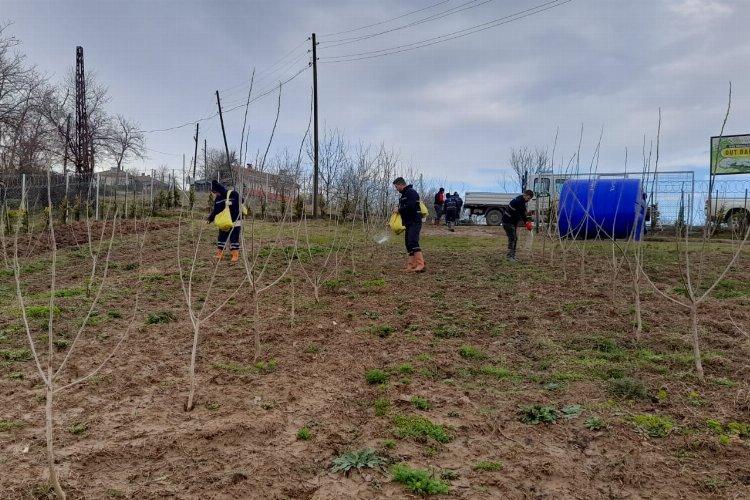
<box><xmin>0</xmin><ymin>0</ymin><xmax>750</xmax><ymax>188</ymax></box>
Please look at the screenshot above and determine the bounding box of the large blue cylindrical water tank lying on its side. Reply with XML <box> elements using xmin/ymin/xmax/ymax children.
<box><xmin>558</xmin><ymin>178</ymin><xmax>646</xmax><ymax>240</ymax></box>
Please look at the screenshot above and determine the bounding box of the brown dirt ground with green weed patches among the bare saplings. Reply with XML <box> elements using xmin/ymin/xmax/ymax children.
<box><xmin>0</xmin><ymin>221</ymin><xmax>750</xmax><ymax>499</ymax></box>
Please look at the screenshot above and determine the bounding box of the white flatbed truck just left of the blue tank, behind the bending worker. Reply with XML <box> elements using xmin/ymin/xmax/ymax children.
<box><xmin>463</xmin><ymin>174</ymin><xmax>568</xmax><ymax>226</ymax></box>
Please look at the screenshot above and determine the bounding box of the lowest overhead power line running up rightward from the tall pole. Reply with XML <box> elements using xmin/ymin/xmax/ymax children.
<box><xmin>320</xmin><ymin>0</ymin><xmax>573</xmax><ymax>64</ymax></box>
